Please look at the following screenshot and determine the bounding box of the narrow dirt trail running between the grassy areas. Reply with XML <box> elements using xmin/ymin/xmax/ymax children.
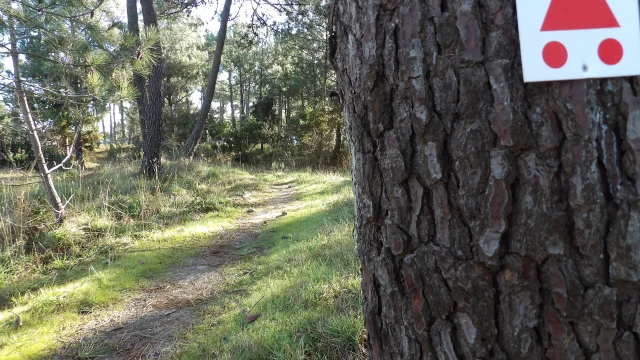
<box><xmin>56</xmin><ymin>182</ymin><xmax>295</xmax><ymax>359</ymax></box>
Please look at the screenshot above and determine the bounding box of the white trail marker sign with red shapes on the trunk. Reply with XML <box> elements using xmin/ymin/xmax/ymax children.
<box><xmin>516</xmin><ymin>0</ymin><xmax>640</xmax><ymax>82</ymax></box>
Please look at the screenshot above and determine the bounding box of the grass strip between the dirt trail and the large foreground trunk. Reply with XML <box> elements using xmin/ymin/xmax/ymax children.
<box><xmin>178</xmin><ymin>175</ymin><xmax>365</xmax><ymax>359</ymax></box>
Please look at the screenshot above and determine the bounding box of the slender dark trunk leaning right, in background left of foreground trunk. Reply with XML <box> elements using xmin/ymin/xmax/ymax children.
<box><xmin>184</xmin><ymin>0</ymin><xmax>235</xmax><ymax>158</ymax></box>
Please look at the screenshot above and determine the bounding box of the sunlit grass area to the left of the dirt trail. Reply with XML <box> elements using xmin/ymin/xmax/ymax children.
<box><xmin>0</xmin><ymin>162</ymin><xmax>273</xmax><ymax>359</ymax></box>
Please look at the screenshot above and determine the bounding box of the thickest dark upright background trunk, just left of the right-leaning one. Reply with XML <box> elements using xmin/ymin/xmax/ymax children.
<box><xmin>140</xmin><ymin>0</ymin><xmax>164</xmax><ymax>177</ymax></box>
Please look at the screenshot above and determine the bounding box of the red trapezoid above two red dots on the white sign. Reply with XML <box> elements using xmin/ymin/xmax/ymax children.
<box><xmin>541</xmin><ymin>0</ymin><xmax>620</xmax><ymax>31</ymax></box>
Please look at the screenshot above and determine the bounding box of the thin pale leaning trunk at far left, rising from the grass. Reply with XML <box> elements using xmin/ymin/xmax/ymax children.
<box><xmin>9</xmin><ymin>15</ymin><xmax>65</xmax><ymax>223</ymax></box>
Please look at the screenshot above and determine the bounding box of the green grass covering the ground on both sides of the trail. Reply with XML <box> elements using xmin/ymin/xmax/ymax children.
<box><xmin>0</xmin><ymin>150</ymin><xmax>364</xmax><ymax>359</ymax></box>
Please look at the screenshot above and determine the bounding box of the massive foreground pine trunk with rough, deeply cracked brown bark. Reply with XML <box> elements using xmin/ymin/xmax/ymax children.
<box><xmin>333</xmin><ymin>0</ymin><xmax>640</xmax><ymax>360</ymax></box>
